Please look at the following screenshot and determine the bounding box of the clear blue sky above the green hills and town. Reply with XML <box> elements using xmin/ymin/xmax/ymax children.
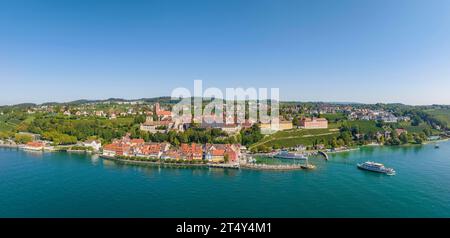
<box><xmin>0</xmin><ymin>0</ymin><xmax>450</xmax><ymax>104</ymax></box>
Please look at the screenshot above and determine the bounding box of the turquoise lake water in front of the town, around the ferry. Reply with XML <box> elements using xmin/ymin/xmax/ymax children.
<box><xmin>0</xmin><ymin>142</ymin><xmax>450</xmax><ymax>217</ymax></box>
